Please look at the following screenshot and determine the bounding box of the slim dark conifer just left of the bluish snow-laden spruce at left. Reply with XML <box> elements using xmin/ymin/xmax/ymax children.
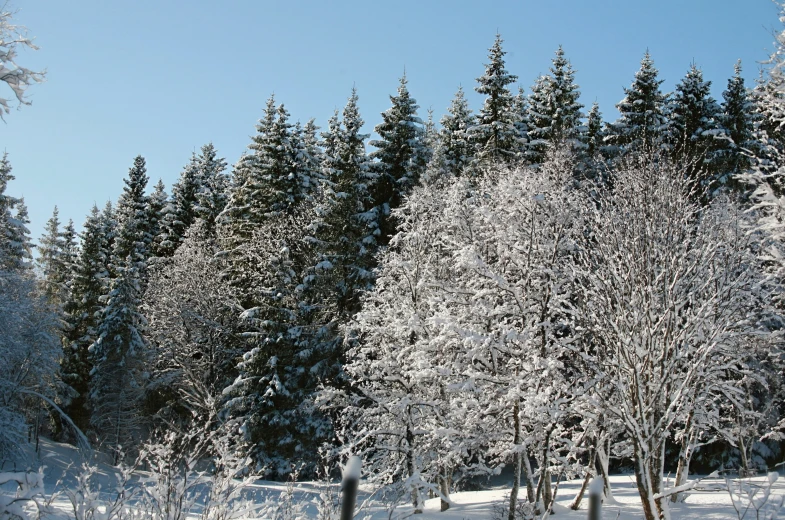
<box><xmin>60</xmin><ymin>206</ymin><xmax>110</xmax><ymax>431</ymax></box>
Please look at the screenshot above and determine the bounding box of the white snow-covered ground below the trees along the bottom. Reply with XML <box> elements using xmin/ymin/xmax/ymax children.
<box><xmin>0</xmin><ymin>439</ymin><xmax>785</xmax><ymax>520</ymax></box>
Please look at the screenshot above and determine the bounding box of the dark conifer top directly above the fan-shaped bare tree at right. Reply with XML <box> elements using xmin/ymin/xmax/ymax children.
<box><xmin>609</xmin><ymin>51</ymin><xmax>668</xmax><ymax>153</ymax></box>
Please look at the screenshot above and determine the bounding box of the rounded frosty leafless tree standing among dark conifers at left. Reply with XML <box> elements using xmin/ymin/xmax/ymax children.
<box><xmin>142</xmin><ymin>220</ymin><xmax>242</xmax><ymax>431</ymax></box>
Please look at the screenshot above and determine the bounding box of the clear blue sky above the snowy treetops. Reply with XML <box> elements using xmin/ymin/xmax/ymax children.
<box><xmin>0</xmin><ymin>0</ymin><xmax>779</xmax><ymax>241</ymax></box>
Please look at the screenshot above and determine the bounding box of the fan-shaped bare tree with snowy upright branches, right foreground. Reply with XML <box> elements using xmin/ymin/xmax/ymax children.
<box><xmin>576</xmin><ymin>155</ymin><xmax>768</xmax><ymax>520</ymax></box>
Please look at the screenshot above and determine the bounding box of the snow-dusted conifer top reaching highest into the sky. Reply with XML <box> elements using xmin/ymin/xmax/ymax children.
<box><xmin>471</xmin><ymin>34</ymin><xmax>521</xmax><ymax>163</ymax></box>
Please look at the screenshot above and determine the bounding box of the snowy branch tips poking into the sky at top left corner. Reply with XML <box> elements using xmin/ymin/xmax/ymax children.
<box><xmin>0</xmin><ymin>4</ymin><xmax>46</xmax><ymax>119</ymax></box>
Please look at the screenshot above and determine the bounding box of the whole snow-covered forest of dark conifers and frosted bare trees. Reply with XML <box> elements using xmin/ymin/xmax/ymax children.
<box><xmin>0</xmin><ymin>7</ymin><xmax>785</xmax><ymax>520</ymax></box>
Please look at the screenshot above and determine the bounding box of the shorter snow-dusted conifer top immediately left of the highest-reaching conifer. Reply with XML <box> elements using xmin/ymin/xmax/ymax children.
<box><xmin>429</xmin><ymin>88</ymin><xmax>474</xmax><ymax>179</ymax></box>
